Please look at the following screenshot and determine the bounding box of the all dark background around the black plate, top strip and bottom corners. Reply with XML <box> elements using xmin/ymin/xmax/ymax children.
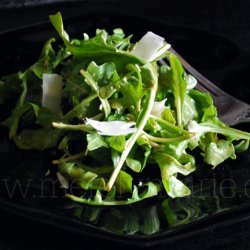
<box><xmin>0</xmin><ymin>0</ymin><xmax>250</xmax><ymax>250</ymax></box>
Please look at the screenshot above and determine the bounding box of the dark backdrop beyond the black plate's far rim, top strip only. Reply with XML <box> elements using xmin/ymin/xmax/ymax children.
<box><xmin>0</xmin><ymin>0</ymin><xmax>250</xmax><ymax>52</ymax></box>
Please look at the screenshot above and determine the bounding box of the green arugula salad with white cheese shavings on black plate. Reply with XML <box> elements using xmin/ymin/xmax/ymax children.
<box><xmin>0</xmin><ymin>13</ymin><xmax>250</xmax><ymax>205</ymax></box>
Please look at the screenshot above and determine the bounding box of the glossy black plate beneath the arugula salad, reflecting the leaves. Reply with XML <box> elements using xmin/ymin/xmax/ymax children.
<box><xmin>0</xmin><ymin>10</ymin><xmax>250</xmax><ymax>246</ymax></box>
